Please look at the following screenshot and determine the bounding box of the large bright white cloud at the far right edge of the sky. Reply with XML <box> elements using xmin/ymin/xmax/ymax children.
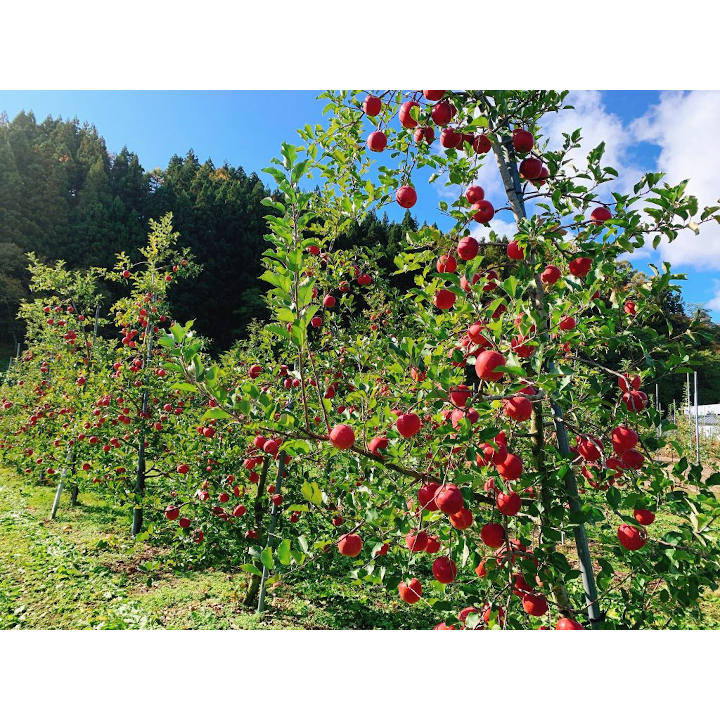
<box><xmin>631</xmin><ymin>91</ymin><xmax>720</xmax><ymax>270</ymax></box>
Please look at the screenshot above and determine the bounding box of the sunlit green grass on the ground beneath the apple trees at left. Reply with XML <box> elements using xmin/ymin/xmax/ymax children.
<box><xmin>0</xmin><ymin>469</ymin><xmax>427</xmax><ymax>630</ymax></box>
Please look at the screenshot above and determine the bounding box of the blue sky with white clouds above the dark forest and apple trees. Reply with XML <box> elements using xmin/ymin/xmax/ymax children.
<box><xmin>0</xmin><ymin>91</ymin><xmax>720</xmax><ymax>321</ymax></box>
